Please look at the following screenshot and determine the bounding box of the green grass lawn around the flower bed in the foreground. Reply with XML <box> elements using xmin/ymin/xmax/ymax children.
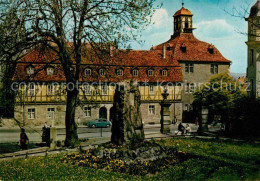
<box><xmin>0</xmin><ymin>138</ymin><xmax>260</xmax><ymax>180</ymax></box>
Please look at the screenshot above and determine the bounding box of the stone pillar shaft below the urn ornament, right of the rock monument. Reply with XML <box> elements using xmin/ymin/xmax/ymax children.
<box><xmin>160</xmin><ymin>101</ymin><xmax>171</xmax><ymax>134</ymax></box>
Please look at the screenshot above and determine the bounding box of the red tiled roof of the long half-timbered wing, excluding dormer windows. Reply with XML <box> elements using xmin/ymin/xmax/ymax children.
<box><xmin>13</xmin><ymin>50</ymin><xmax>182</xmax><ymax>82</ymax></box>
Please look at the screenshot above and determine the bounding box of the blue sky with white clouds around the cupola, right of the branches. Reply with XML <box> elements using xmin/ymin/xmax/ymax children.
<box><xmin>131</xmin><ymin>0</ymin><xmax>256</xmax><ymax>73</ymax></box>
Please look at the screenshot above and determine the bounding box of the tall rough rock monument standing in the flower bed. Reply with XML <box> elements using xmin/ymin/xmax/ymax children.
<box><xmin>111</xmin><ymin>82</ymin><xmax>144</xmax><ymax>145</ymax></box>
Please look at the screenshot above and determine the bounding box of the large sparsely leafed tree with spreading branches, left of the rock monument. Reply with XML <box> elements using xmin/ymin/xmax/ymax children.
<box><xmin>1</xmin><ymin>0</ymin><xmax>155</xmax><ymax>146</ymax></box>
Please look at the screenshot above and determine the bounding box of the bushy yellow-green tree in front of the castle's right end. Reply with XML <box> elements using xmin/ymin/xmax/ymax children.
<box><xmin>193</xmin><ymin>74</ymin><xmax>246</xmax><ymax>132</ymax></box>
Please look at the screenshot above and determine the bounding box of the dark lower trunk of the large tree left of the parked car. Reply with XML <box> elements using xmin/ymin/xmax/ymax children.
<box><xmin>65</xmin><ymin>87</ymin><xmax>79</xmax><ymax>147</ymax></box>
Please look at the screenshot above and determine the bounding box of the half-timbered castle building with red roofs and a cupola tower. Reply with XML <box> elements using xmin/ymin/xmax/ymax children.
<box><xmin>13</xmin><ymin>4</ymin><xmax>231</xmax><ymax>125</ymax></box>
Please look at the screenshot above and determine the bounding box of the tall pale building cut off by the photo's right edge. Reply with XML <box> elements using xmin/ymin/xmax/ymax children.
<box><xmin>246</xmin><ymin>0</ymin><xmax>260</xmax><ymax>98</ymax></box>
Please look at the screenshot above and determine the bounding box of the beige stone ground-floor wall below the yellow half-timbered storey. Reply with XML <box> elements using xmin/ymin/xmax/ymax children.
<box><xmin>15</xmin><ymin>102</ymin><xmax>182</xmax><ymax>126</ymax></box>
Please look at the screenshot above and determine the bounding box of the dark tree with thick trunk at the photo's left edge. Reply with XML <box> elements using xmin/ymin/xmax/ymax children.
<box><xmin>0</xmin><ymin>9</ymin><xmax>31</xmax><ymax>117</ymax></box>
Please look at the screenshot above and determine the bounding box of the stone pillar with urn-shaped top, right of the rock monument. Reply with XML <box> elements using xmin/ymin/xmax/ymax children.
<box><xmin>160</xmin><ymin>87</ymin><xmax>171</xmax><ymax>134</ymax></box>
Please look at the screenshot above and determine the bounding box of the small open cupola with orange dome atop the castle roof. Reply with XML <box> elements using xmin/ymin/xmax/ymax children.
<box><xmin>173</xmin><ymin>3</ymin><xmax>194</xmax><ymax>35</ymax></box>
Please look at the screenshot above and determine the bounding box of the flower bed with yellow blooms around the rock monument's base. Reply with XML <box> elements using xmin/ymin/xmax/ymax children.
<box><xmin>62</xmin><ymin>142</ymin><xmax>182</xmax><ymax>175</ymax></box>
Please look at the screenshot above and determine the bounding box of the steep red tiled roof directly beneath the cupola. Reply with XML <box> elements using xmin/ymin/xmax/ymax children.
<box><xmin>151</xmin><ymin>33</ymin><xmax>231</xmax><ymax>63</ymax></box>
